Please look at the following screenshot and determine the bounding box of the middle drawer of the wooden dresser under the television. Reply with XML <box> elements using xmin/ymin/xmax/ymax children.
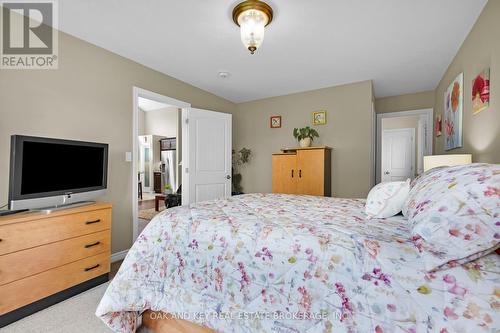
<box><xmin>0</xmin><ymin>230</ymin><xmax>111</xmax><ymax>285</ymax></box>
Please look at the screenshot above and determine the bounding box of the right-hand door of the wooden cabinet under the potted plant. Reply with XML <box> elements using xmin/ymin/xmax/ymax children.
<box><xmin>297</xmin><ymin>149</ymin><xmax>325</xmax><ymax>196</ymax></box>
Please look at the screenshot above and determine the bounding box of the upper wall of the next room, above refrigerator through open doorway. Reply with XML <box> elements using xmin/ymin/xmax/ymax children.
<box><xmin>144</xmin><ymin>107</ymin><xmax>179</xmax><ymax>138</ymax></box>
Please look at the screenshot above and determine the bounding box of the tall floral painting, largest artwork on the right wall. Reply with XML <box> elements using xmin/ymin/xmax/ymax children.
<box><xmin>444</xmin><ymin>73</ymin><xmax>464</xmax><ymax>150</ymax></box>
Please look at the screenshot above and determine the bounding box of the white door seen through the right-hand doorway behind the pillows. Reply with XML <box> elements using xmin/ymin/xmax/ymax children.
<box><xmin>381</xmin><ymin>128</ymin><xmax>415</xmax><ymax>182</ymax></box>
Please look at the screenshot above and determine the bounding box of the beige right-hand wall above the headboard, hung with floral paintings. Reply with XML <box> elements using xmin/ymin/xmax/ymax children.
<box><xmin>434</xmin><ymin>0</ymin><xmax>500</xmax><ymax>163</ymax></box>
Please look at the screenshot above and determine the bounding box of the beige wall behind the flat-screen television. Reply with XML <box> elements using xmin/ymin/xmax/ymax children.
<box><xmin>0</xmin><ymin>33</ymin><xmax>235</xmax><ymax>252</ymax></box>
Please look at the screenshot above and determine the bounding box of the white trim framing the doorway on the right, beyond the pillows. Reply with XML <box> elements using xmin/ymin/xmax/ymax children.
<box><xmin>375</xmin><ymin>109</ymin><xmax>434</xmax><ymax>184</ymax></box>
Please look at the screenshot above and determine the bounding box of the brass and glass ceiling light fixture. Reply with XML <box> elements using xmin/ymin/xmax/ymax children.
<box><xmin>233</xmin><ymin>0</ymin><xmax>273</xmax><ymax>54</ymax></box>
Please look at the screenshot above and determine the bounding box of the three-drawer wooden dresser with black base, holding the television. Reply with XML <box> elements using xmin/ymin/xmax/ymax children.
<box><xmin>0</xmin><ymin>203</ymin><xmax>111</xmax><ymax>327</ymax></box>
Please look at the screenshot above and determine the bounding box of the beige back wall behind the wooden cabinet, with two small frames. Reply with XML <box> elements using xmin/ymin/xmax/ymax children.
<box><xmin>233</xmin><ymin>81</ymin><xmax>373</xmax><ymax>197</ymax></box>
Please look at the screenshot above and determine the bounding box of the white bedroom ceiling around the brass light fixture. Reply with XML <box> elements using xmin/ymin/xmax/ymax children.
<box><xmin>59</xmin><ymin>0</ymin><xmax>487</xmax><ymax>102</ymax></box>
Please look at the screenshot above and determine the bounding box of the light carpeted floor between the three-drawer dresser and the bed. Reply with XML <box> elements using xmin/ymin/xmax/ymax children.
<box><xmin>0</xmin><ymin>283</ymin><xmax>112</xmax><ymax>333</ymax></box>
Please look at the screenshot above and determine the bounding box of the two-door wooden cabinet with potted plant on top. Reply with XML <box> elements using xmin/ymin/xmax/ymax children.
<box><xmin>272</xmin><ymin>146</ymin><xmax>332</xmax><ymax>197</ymax></box>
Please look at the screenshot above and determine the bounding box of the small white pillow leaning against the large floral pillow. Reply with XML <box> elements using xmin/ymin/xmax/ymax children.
<box><xmin>365</xmin><ymin>179</ymin><xmax>410</xmax><ymax>219</ymax></box>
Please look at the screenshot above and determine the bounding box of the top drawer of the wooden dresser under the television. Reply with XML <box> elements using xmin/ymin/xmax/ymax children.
<box><xmin>0</xmin><ymin>209</ymin><xmax>111</xmax><ymax>255</ymax></box>
